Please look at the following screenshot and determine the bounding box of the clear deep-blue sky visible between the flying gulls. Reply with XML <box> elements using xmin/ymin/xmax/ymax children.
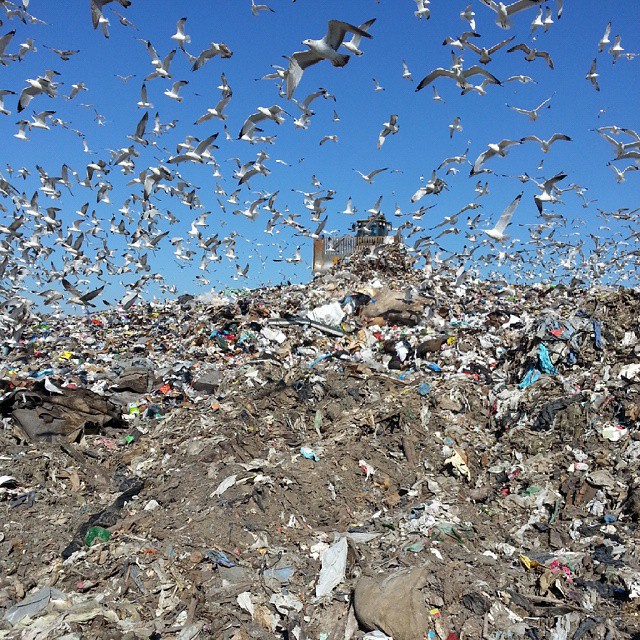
<box><xmin>0</xmin><ymin>0</ymin><xmax>640</xmax><ymax>300</ymax></box>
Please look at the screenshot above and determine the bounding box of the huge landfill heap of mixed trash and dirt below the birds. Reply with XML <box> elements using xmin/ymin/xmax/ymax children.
<box><xmin>0</xmin><ymin>257</ymin><xmax>640</xmax><ymax>640</ymax></box>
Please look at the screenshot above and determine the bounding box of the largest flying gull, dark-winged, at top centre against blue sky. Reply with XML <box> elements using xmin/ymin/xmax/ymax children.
<box><xmin>287</xmin><ymin>20</ymin><xmax>372</xmax><ymax>100</ymax></box>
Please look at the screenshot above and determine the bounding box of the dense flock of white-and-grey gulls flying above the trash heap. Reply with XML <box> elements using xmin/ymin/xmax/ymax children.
<box><xmin>0</xmin><ymin>0</ymin><xmax>640</xmax><ymax>330</ymax></box>
